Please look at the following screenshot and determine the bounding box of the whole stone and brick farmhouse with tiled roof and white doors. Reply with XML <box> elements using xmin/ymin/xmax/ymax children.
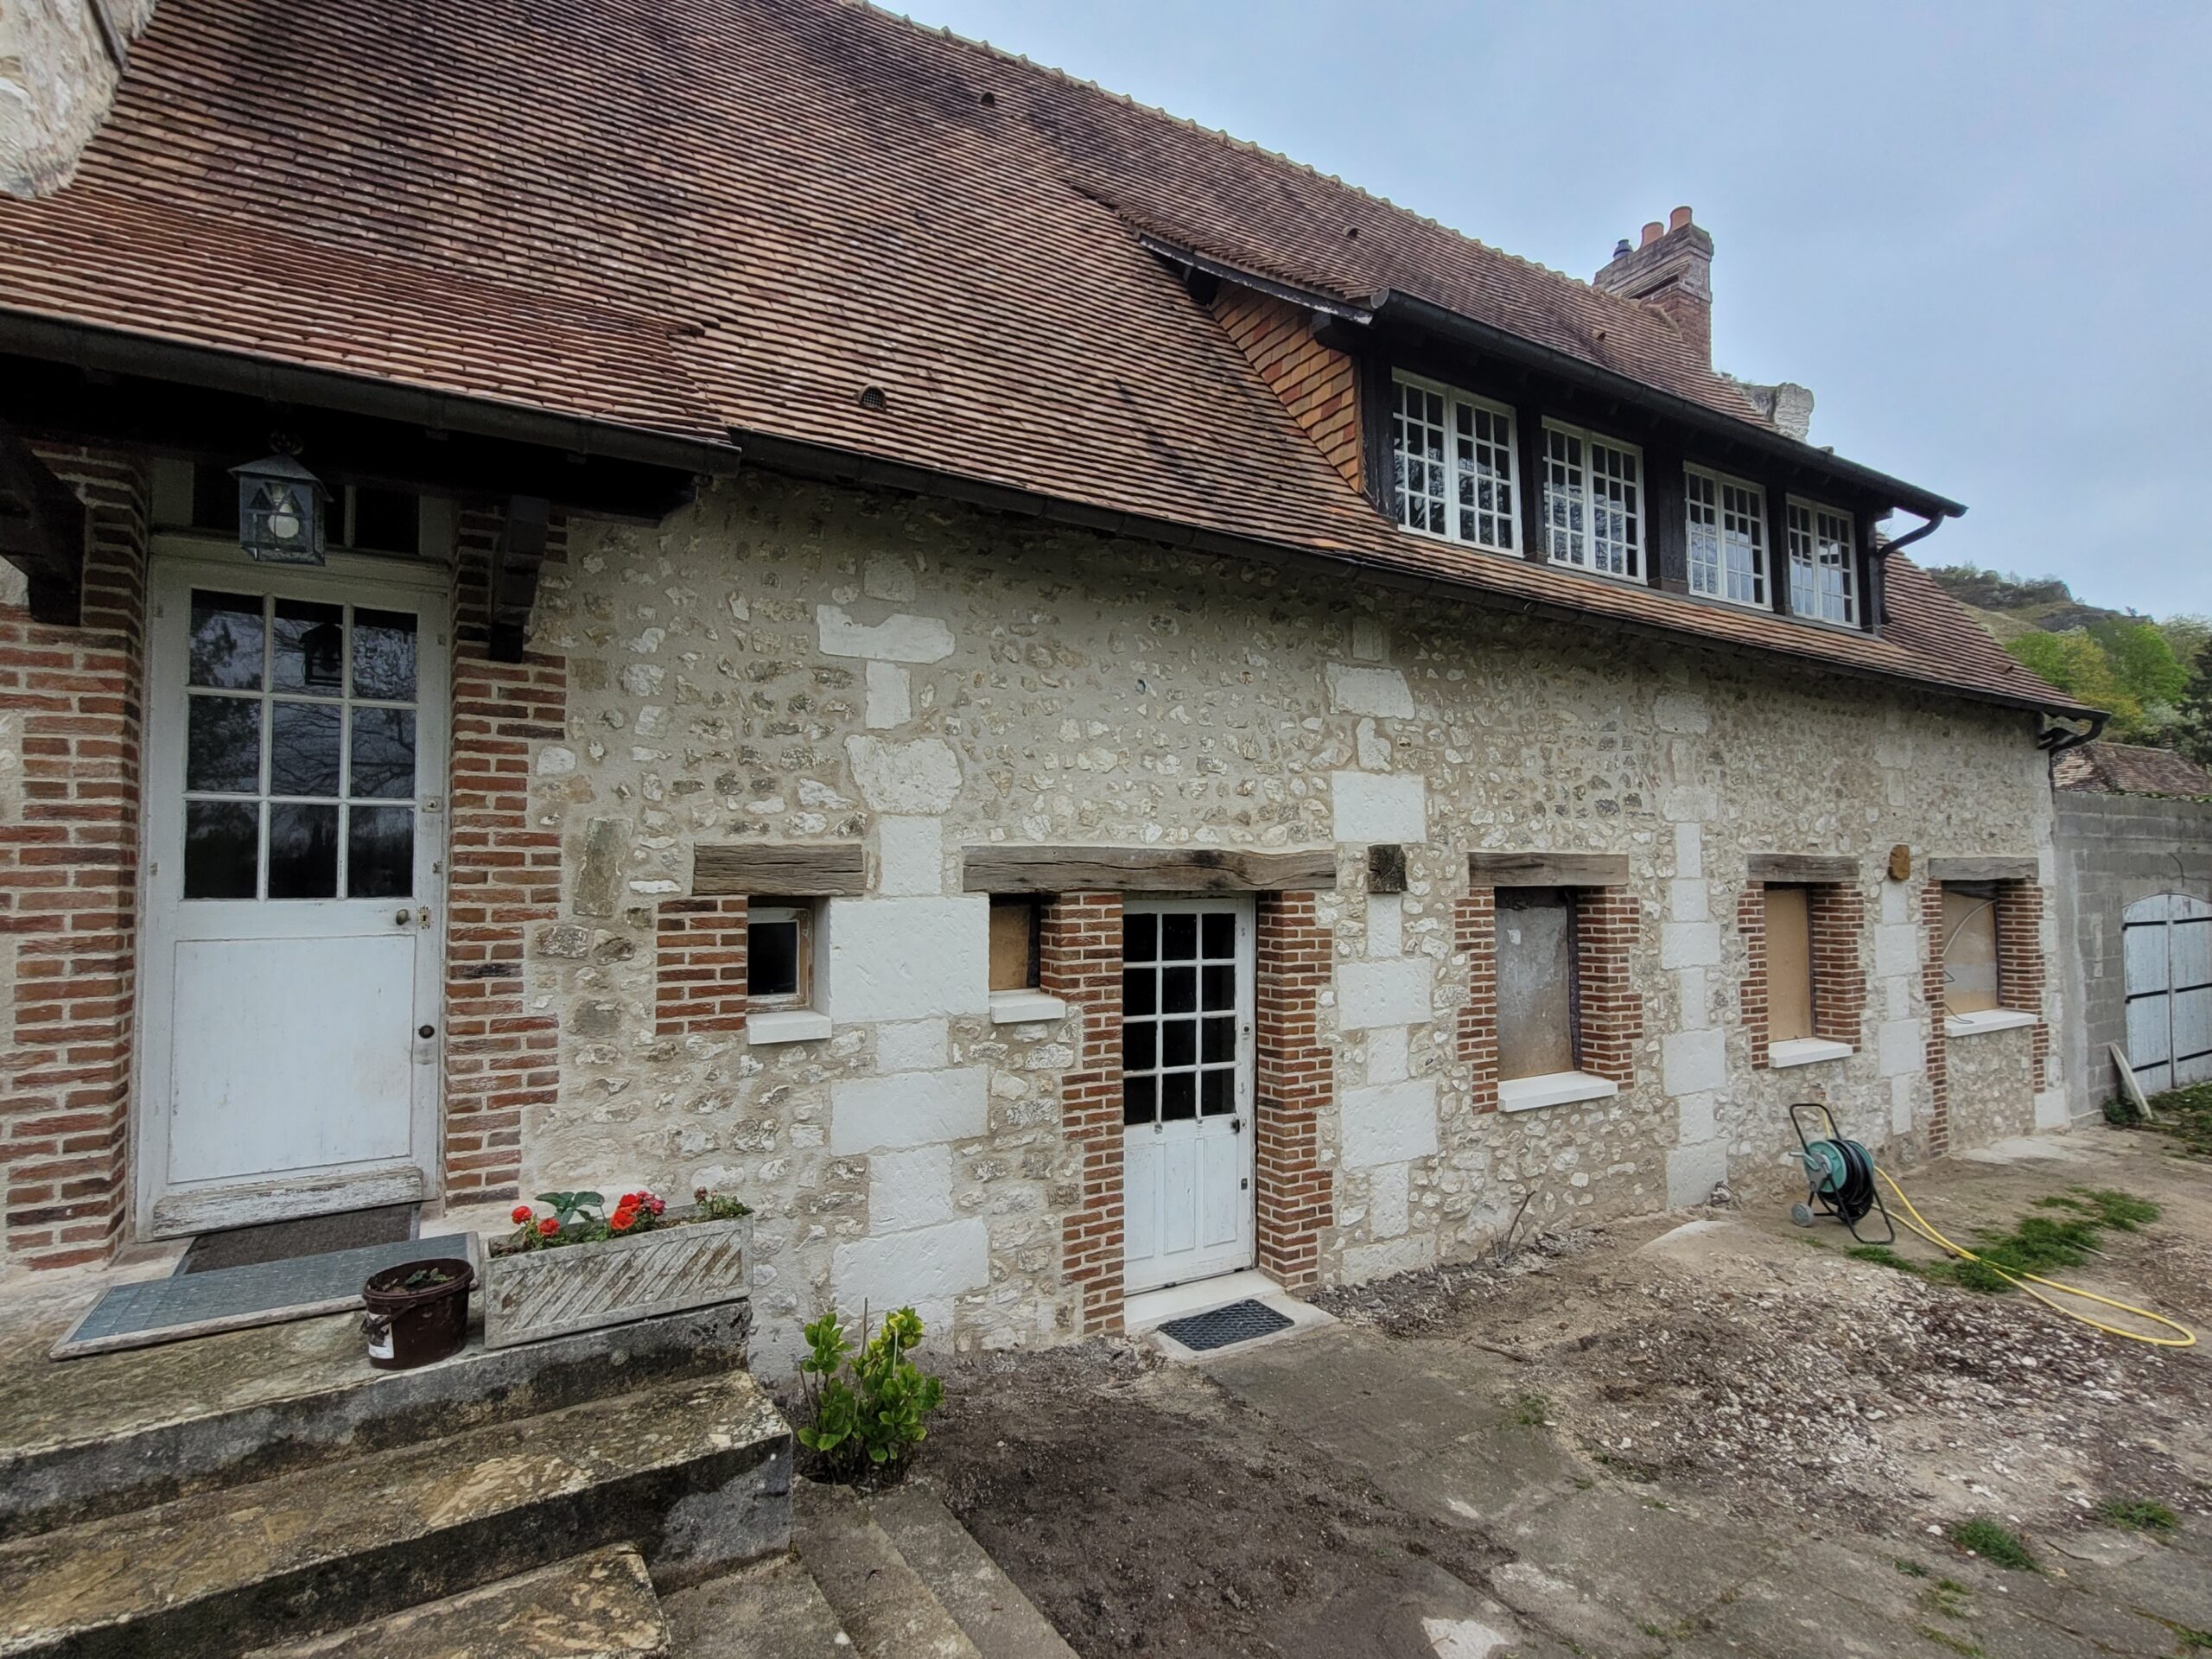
<box><xmin>0</xmin><ymin>0</ymin><xmax>2097</xmax><ymax>1363</ymax></box>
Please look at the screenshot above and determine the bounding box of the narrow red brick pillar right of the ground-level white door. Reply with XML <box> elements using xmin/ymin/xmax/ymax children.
<box><xmin>1252</xmin><ymin>893</ymin><xmax>1336</xmax><ymax>1289</ymax></box>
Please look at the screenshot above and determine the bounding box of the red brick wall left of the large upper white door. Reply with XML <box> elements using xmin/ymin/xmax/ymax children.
<box><xmin>0</xmin><ymin>449</ymin><xmax>149</xmax><ymax>1268</ymax></box>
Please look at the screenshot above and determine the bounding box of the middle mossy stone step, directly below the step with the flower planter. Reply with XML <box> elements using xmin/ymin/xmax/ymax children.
<box><xmin>0</xmin><ymin>1371</ymin><xmax>791</xmax><ymax>1659</ymax></box>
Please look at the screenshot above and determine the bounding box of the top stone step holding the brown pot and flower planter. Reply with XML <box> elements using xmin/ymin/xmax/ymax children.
<box><xmin>0</xmin><ymin>1303</ymin><xmax>752</xmax><ymax>1540</ymax></box>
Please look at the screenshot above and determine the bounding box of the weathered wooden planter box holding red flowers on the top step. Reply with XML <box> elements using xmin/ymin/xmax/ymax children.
<box><xmin>485</xmin><ymin>1214</ymin><xmax>752</xmax><ymax>1347</ymax></box>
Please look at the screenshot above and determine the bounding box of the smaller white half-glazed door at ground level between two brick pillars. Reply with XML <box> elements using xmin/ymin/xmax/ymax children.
<box><xmin>1122</xmin><ymin>898</ymin><xmax>1255</xmax><ymax>1292</ymax></box>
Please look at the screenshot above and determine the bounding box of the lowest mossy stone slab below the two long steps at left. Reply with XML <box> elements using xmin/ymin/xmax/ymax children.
<box><xmin>245</xmin><ymin>1544</ymin><xmax>668</xmax><ymax>1659</ymax></box>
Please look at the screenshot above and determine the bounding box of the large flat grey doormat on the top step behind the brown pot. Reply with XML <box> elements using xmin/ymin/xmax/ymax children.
<box><xmin>53</xmin><ymin>1232</ymin><xmax>475</xmax><ymax>1360</ymax></box>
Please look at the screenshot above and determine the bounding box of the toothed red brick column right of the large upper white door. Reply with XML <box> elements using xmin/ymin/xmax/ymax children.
<box><xmin>445</xmin><ymin>509</ymin><xmax>569</xmax><ymax>1204</ymax></box>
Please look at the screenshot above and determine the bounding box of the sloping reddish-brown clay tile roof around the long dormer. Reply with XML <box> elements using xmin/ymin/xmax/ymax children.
<box><xmin>0</xmin><ymin>0</ymin><xmax>2070</xmax><ymax>710</ymax></box>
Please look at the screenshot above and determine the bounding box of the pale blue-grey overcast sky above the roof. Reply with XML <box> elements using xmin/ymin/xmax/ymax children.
<box><xmin>892</xmin><ymin>0</ymin><xmax>2212</xmax><ymax>615</ymax></box>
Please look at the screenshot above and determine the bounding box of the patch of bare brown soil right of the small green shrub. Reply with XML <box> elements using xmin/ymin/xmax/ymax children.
<box><xmin>925</xmin><ymin>1343</ymin><xmax>1502</xmax><ymax>1659</ymax></box>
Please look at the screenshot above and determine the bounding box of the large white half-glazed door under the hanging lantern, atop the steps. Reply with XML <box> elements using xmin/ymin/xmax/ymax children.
<box><xmin>139</xmin><ymin>560</ymin><xmax>445</xmax><ymax>1234</ymax></box>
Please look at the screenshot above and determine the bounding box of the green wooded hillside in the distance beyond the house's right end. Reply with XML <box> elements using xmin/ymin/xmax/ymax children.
<box><xmin>1929</xmin><ymin>564</ymin><xmax>2212</xmax><ymax>766</ymax></box>
